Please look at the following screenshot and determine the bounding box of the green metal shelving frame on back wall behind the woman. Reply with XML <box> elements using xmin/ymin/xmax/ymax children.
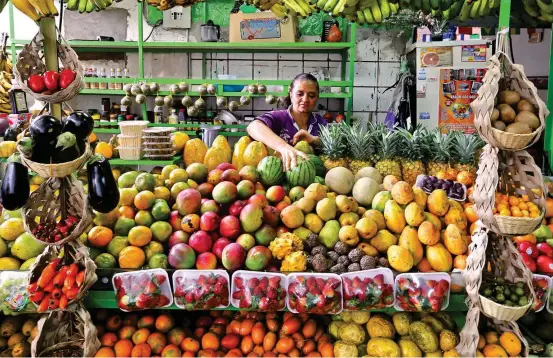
<box><xmin>9</xmin><ymin>2</ymin><xmax>357</xmax><ymax>124</ymax></box>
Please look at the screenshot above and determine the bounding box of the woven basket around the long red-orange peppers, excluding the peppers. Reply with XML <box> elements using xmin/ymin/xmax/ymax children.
<box><xmin>29</xmin><ymin>242</ymin><xmax>98</xmax><ymax>312</ymax></box>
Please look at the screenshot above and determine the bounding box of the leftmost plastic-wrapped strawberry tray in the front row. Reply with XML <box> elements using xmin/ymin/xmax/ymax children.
<box><xmin>111</xmin><ymin>269</ymin><xmax>173</xmax><ymax>312</ymax></box>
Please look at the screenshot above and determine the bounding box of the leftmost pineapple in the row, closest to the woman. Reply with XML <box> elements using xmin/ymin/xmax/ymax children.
<box><xmin>319</xmin><ymin>123</ymin><xmax>348</xmax><ymax>170</ymax></box>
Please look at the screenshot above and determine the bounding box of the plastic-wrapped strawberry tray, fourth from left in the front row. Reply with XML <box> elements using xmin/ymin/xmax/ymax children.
<box><xmin>287</xmin><ymin>273</ymin><xmax>342</xmax><ymax>314</ymax></box>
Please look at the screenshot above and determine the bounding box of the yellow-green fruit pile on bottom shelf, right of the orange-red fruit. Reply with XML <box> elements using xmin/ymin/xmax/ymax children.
<box><xmin>328</xmin><ymin>312</ymin><xmax>459</xmax><ymax>357</ymax></box>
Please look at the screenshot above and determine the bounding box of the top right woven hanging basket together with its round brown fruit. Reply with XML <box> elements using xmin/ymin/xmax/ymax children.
<box><xmin>471</xmin><ymin>29</ymin><xmax>549</xmax><ymax>150</ymax></box>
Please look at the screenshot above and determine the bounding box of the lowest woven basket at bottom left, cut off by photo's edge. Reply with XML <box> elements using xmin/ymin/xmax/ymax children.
<box><xmin>31</xmin><ymin>304</ymin><xmax>101</xmax><ymax>357</ymax></box>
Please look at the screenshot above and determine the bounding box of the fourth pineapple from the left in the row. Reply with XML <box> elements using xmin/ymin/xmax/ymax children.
<box><xmin>398</xmin><ymin>126</ymin><xmax>429</xmax><ymax>185</ymax></box>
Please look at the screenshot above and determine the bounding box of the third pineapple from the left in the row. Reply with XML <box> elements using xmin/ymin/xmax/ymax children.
<box><xmin>374</xmin><ymin>127</ymin><xmax>401</xmax><ymax>180</ymax></box>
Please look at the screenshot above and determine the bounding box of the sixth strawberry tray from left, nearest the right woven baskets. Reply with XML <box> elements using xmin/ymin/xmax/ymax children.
<box><xmin>394</xmin><ymin>272</ymin><xmax>451</xmax><ymax>312</ymax></box>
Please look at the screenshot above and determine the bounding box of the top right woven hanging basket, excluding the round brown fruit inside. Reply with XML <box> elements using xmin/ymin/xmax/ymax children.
<box><xmin>470</xmin><ymin>34</ymin><xmax>549</xmax><ymax>150</ymax></box>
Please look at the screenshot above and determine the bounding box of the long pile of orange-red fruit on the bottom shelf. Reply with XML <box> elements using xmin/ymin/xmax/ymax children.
<box><xmin>95</xmin><ymin>310</ymin><xmax>333</xmax><ymax>357</ymax></box>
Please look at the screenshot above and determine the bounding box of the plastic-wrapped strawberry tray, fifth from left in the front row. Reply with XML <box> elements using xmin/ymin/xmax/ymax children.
<box><xmin>340</xmin><ymin>268</ymin><xmax>394</xmax><ymax>311</ymax></box>
